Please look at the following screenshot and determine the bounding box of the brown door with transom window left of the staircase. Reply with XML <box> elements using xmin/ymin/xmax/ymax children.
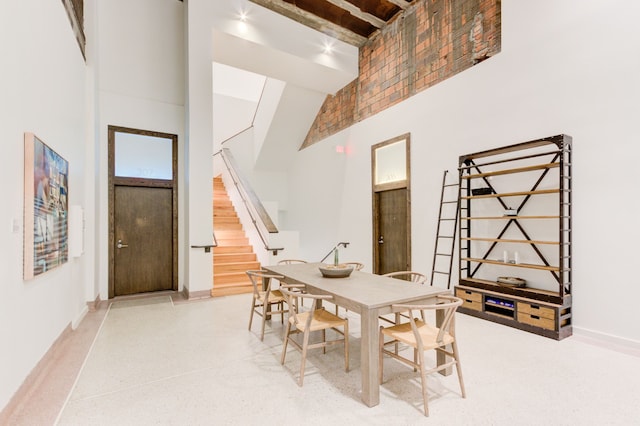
<box><xmin>109</xmin><ymin>126</ymin><xmax>178</xmax><ymax>298</ymax></box>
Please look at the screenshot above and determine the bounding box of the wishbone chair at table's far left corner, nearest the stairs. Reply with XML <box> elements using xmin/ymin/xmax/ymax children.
<box><xmin>247</xmin><ymin>271</ymin><xmax>289</xmax><ymax>340</ymax></box>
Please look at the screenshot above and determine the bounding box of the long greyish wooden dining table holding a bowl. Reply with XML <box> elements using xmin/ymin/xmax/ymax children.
<box><xmin>263</xmin><ymin>263</ymin><xmax>449</xmax><ymax>407</ymax></box>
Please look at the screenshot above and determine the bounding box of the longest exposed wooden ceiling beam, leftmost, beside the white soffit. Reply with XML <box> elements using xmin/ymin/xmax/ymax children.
<box><xmin>250</xmin><ymin>0</ymin><xmax>367</xmax><ymax>47</ymax></box>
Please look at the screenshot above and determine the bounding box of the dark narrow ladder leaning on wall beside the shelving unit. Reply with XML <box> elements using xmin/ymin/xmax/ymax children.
<box><xmin>430</xmin><ymin>170</ymin><xmax>460</xmax><ymax>288</ymax></box>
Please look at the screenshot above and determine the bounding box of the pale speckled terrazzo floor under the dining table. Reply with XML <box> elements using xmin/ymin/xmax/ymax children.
<box><xmin>9</xmin><ymin>295</ymin><xmax>640</xmax><ymax>426</ymax></box>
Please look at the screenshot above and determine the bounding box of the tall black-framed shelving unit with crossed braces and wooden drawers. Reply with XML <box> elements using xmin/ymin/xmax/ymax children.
<box><xmin>455</xmin><ymin>135</ymin><xmax>572</xmax><ymax>340</ymax></box>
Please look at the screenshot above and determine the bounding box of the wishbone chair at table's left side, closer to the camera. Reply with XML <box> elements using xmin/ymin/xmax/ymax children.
<box><xmin>280</xmin><ymin>287</ymin><xmax>349</xmax><ymax>386</ymax></box>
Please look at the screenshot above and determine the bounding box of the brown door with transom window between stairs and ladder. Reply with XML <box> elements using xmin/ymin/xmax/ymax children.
<box><xmin>371</xmin><ymin>134</ymin><xmax>411</xmax><ymax>274</ymax></box>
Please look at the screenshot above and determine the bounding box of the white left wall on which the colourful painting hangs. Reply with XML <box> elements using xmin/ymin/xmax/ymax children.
<box><xmin>0</xmin><ymin>0</ymin><xmax>90</xmax><ymax>407</ymax></box>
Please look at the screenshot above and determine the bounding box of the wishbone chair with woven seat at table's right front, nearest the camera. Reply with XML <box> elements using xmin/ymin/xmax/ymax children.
<box><xmin>379</xmin><ymin>296</ymin><xmax>466</xmax><ymax>416</ymax></box>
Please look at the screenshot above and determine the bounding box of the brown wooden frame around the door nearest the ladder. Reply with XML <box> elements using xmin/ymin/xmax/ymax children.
<box><xmin>371</xmin><ymin>133</ymin><xmax>411</xmax><ymax>273</ymax></box>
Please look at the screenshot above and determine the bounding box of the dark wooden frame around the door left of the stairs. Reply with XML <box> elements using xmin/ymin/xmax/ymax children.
<box><xmin>108</xmin><ymin>125</ymin><xmax>178</xmax><ymax>299</ymax></box>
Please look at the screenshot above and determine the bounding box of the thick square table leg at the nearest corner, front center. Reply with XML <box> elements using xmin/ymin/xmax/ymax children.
<box><xmin>360</xmin><ymin>310</ymin><xmax>380</xmax><ymax>407</ymax></box>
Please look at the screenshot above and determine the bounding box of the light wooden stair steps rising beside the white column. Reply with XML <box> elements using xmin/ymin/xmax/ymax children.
<box><xmin>211</xmin><ymin>176</ymin><xmax>260</xmax><ymax>297</ymax></box>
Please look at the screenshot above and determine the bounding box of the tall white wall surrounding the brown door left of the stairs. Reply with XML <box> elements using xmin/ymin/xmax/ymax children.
<box><xmin>95</xmin><ymin>0</ymin><xmax>188</xmax><ymax>300</ymax></box>
